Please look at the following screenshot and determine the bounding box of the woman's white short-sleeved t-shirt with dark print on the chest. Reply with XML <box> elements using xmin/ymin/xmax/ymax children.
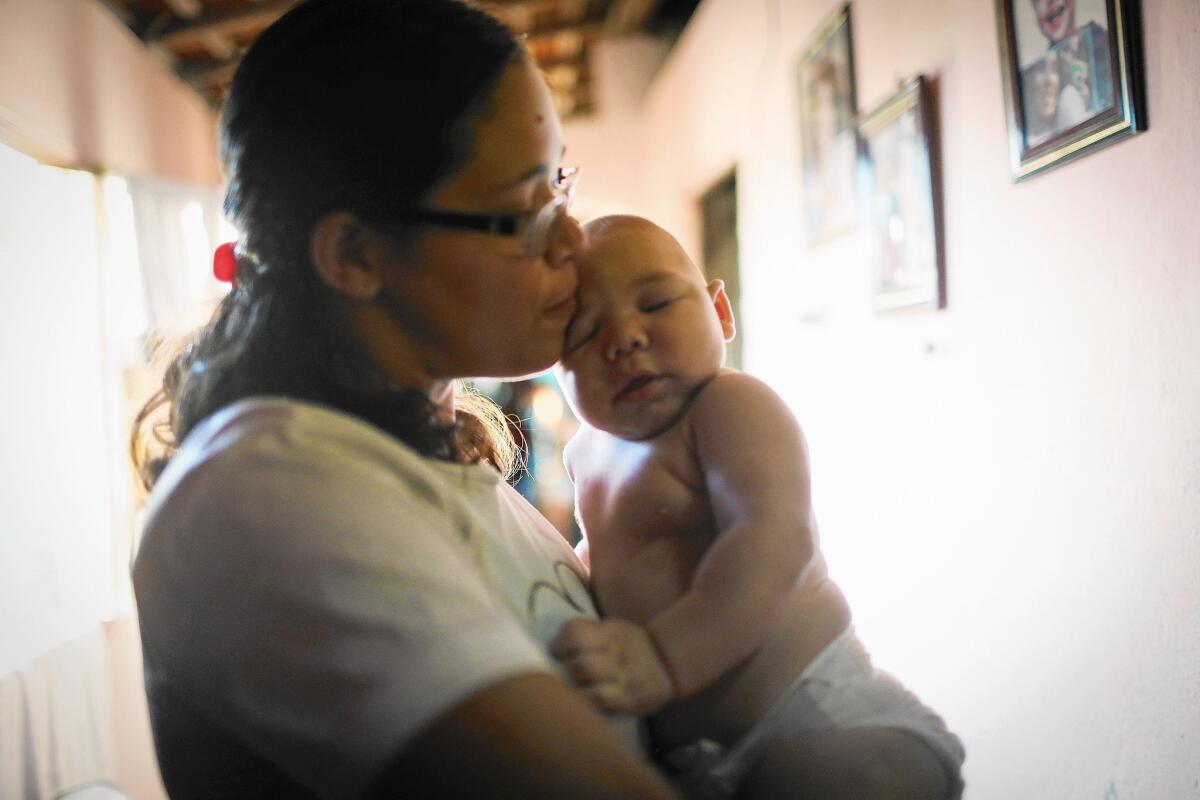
<box><xmin>133</xmin><ymin>398</ymin><xmax>636</xmax><ymax>798</ymax></box>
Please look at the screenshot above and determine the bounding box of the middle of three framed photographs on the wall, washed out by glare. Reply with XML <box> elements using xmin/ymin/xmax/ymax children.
<box><xmin>862</xmin><ymin>76</ymin><xmax>946</xmax><ymax>311</ymax></box>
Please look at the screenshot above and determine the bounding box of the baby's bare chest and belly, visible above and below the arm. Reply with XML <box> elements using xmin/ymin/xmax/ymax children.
<box><xmin>566</xmin><ymin>373</ymin><xmax>850</xmax><ymax>746</ymax></box>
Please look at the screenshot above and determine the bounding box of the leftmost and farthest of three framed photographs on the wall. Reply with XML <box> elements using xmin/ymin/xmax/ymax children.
<box><xmin>799</xmin><ymin>5</ymin><xmax>862</xmax><ymax>243</ymax></box>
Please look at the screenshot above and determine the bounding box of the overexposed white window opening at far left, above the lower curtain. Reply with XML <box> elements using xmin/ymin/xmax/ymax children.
<box><xmin>0</xmin><ymin>142</ymin><xmax>115</xmax><ymax>675</ymax></box>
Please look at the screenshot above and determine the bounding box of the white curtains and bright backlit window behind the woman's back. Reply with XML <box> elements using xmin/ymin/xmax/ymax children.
<box><xmin>0</xmin><ymin>146</ymin><xmax>223</xmax><ymax>799</ymax></box>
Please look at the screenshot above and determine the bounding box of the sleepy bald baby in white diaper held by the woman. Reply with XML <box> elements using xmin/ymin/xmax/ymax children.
<box><xmin>552</xmin><ymin>216</ymin><xmax>964</xmax><ymax>800</ymax></box>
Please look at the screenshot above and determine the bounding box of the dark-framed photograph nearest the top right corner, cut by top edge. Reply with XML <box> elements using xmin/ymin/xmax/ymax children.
<box><xmin>996</xmin><ymin>0</ymin><xmax>1146</xmax><ymax>180</ymax></box>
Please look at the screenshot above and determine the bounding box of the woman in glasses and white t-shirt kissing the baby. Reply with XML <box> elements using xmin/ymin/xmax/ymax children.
<box><xmin>134</xmin><ymin>0</ymin><xmax>670</xmax><ymax>798</ymax></box>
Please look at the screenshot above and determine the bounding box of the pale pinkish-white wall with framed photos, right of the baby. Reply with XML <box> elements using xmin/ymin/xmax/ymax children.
<box><xmin>568</xmin><ymin>0</ymin><xmax>1200</xmax><ymax>800</ymax></box>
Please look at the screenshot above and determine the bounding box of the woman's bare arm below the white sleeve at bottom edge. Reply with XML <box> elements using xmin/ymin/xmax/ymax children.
<box><xmin>367</xmin><ymin>673</ymin><xmax>676</xmax><ymax>800</ymax></box>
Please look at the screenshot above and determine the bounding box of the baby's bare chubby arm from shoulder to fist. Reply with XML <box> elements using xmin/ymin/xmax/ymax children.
<box><xmin>551</xmin><ymin>373</ymin><xmax>815</xmax><ymax>714</ymax></box>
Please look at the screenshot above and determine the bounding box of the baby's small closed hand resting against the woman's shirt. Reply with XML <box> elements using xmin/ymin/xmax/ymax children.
<box><xmin>550</xmin><ymin>619</ymin><xmax>673</xmax><ymax>715</ymax></box>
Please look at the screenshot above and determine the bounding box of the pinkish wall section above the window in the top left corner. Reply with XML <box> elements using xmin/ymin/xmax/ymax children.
<box><xmin>0</xmin><ymin>0</ymin><xmax>220</xmax><ymax>186</ymax></box>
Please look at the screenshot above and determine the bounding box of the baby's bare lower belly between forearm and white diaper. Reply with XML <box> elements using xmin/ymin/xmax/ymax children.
<box><xmin>650</xmin><ymin>565</ymin><xmax>851</xmax><ymax>748</ymax></box>
